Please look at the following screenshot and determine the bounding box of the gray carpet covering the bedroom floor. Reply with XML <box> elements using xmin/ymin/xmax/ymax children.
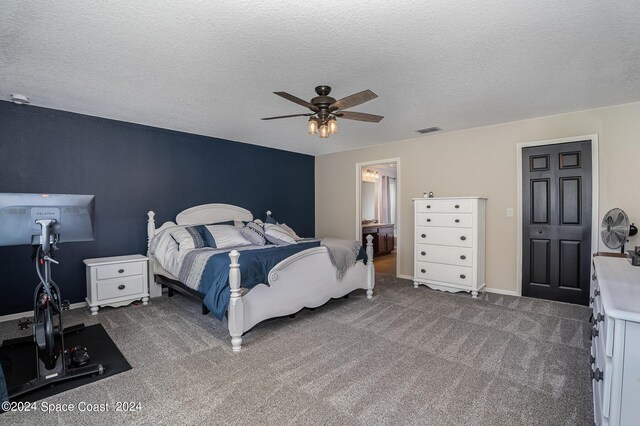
<box><xmin>0</xmin><ymin>275</ymin><xmax>593</xmax><ymax>425</ymax></box>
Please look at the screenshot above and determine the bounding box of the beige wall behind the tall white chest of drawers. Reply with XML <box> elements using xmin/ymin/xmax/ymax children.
<box><xmin>316</xmin><ymin>103</ymin><xmax>640</xmax><ymax>292</ymax></box>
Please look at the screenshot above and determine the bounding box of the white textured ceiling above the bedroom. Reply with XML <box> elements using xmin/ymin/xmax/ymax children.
<box><xmin>0</xmin><ymin>0</ymin><xmax>640</xmax><ymax>155</ymax></box>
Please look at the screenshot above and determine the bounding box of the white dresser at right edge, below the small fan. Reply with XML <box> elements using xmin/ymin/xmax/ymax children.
<box><xmin>589</xmin><ymin>255</ymin><xmax>640</xmax><ymax>426</ymax></box>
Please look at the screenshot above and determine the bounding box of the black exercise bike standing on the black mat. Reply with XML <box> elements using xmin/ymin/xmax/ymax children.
<box><xmin>9</xmin><ymin>219</ymin><xmax>104</xmax><ymax>399</ymax></box>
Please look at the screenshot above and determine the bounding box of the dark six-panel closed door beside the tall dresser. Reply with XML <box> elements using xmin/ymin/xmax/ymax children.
<box><xmin>522</xmin><ymin>141</ymin><xmax>592</xmax><ymax>305</ymax></box>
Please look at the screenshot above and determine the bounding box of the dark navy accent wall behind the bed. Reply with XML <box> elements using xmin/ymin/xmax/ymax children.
<box><xmin>0</xmin><ymin>101</ymin><xmax>315</xmax><ymax>315</ymax></box>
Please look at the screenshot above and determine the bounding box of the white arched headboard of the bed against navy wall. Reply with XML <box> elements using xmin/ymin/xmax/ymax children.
<box><xmin>147</xmin><ymin>204</ymin><xmax>253</xmax><ymax>250</ymax></box>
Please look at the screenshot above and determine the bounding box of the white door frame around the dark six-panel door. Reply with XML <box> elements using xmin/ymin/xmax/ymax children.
<box><xmin>516</xmin><ymin>133</ymin><xmax>600</xmax><ymax>296</ymax></box>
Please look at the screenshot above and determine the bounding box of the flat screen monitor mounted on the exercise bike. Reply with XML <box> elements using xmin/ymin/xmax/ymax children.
<box><xmin>0</xmin><ymin>193</ymin><xmax>95</xmax><ymax>246</ymax></box>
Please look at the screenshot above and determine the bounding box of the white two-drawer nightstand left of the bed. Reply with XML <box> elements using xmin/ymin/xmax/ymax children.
<box><xmin>84</xmin><ymin>254</ymin><xmax>149</xmax><ymax>315</ymax></box>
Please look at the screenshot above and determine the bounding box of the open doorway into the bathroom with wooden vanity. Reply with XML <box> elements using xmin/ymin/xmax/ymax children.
<box><xmin>356</xmin><ymin>158</ymin><xmax>400</xmax><ymax>276</ymax></box>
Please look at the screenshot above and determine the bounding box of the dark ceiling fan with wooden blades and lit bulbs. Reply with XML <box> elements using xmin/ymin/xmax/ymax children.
<box><xmin>262</xmin><ymin>85</ymin><xmax>384</xmax><ymax>139</ymax></box>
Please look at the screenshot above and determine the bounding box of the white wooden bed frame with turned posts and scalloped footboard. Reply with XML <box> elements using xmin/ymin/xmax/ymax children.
<box><xmin>147</xmin><ymin>204</ymin><xmax>375</xmax><ymax>352</ymax></box>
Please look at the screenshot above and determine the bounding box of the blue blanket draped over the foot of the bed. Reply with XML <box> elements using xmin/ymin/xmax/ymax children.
<box><xmin>198</xmin><ymin>241</ymin><xmax>366</xmax><ymax>320</ymax></box>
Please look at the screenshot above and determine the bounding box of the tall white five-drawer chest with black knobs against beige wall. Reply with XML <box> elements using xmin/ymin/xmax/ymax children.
<box><xmin>413</xmin><ymin>197</ymin><xmax>486</xmax><ymax>297</ymax></box>
